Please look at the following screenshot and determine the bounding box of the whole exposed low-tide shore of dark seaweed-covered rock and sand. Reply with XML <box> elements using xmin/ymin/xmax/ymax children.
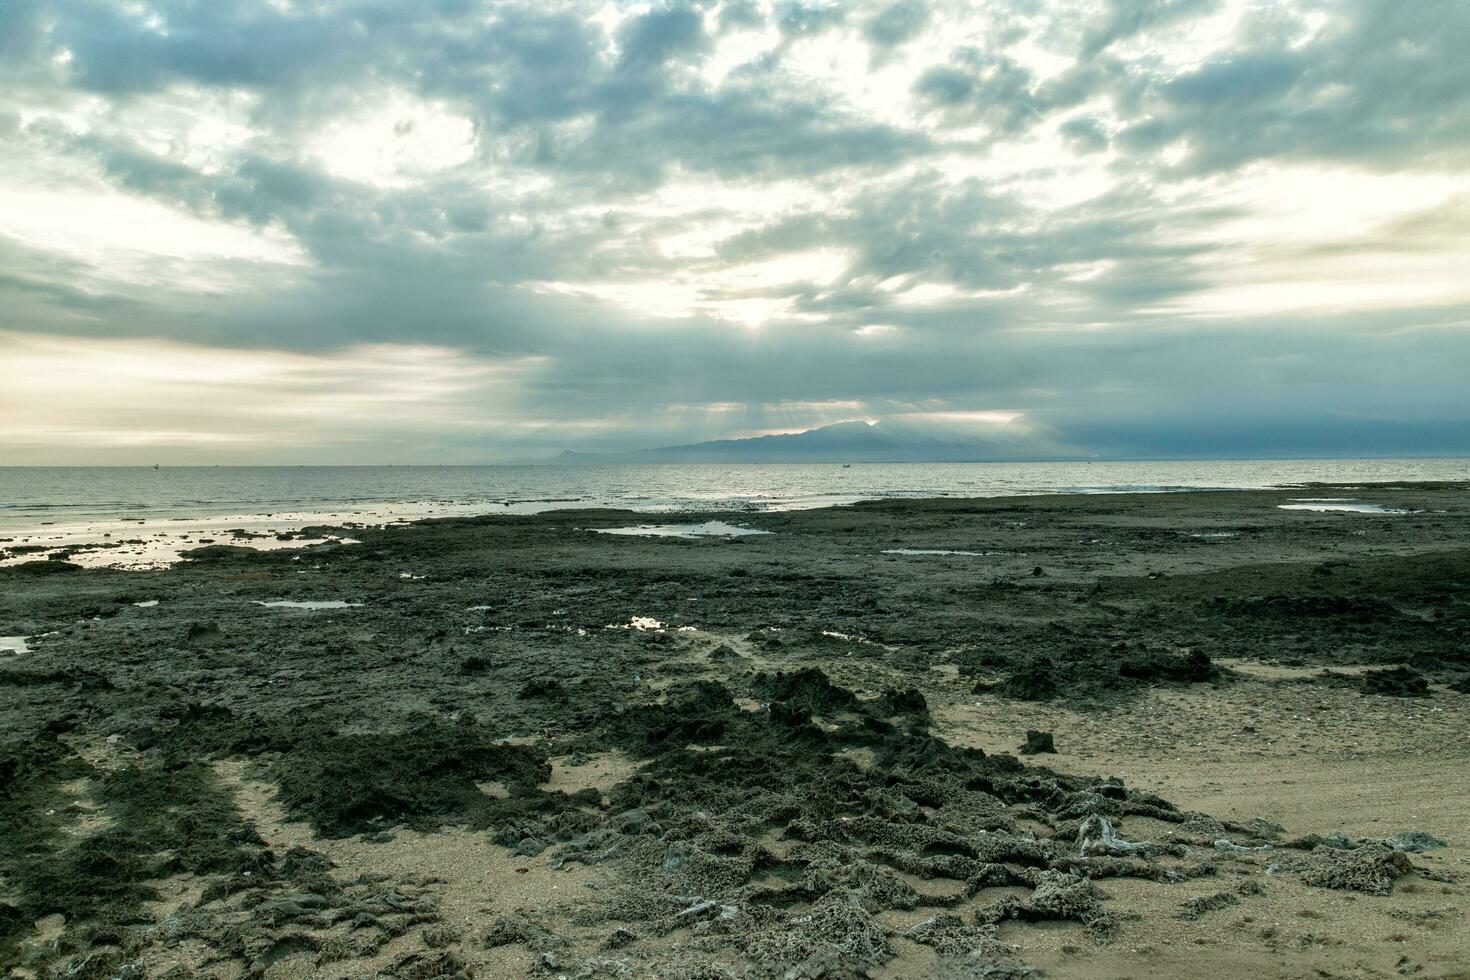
<box><xmin>0</xmin><ymin>485</ymin><xmax>1470</xmax><ymax>977</ymax></box>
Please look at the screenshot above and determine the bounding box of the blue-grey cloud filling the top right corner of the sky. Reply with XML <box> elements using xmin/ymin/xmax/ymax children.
<box><xmin>1120</xmin><ymin>0</ymin><xmax>1470</xmax><ymax>176</ymax></box>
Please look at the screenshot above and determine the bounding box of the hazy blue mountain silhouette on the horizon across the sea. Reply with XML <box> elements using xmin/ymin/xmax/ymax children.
<box><xmin>547</xmin><ymin>422</ymin><xmax>995</xmax><ymax>463</ymax></box>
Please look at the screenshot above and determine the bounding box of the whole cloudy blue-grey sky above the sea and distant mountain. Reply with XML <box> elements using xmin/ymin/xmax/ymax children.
<box><xmin>0</xmin><ymin>0</ymin><xmax>1470</xmax><ymax>464</ymax></box>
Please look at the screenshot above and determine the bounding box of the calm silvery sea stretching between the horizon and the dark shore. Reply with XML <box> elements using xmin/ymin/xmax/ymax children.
<box><xmin>0</xmin><ymin>458</ymin><xmax>1470</xmax><ymax>566</ymax></box>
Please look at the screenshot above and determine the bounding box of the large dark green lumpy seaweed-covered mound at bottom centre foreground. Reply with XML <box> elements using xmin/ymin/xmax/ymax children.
<box><xmin>495</xmin><ymin>670</ymin><xmax>1299</xmax><ymax>977</ymax></box>
